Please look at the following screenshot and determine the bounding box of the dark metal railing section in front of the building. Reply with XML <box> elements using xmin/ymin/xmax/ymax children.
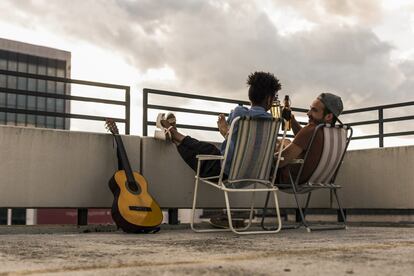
<box><xmin>0</xmin><ymin>70</ymin><xmax>131</xmax><ymax>134</ymax></box>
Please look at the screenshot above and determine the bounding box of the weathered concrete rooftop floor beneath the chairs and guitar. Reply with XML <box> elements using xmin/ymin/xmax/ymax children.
<box><xmin>0</xmin><ymin>225</ymin><xmax>414</xmax><ymax>275</ymax></box>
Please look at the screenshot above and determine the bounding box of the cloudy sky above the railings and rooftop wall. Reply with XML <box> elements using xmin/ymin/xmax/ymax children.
<box><xmin>0</xmin><ymin>0</ymin><xmax>414</xmax><ymax>143</ymax></box>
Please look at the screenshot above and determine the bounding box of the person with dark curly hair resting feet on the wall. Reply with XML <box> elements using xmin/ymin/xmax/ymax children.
<box><xmin>159</xmin><ymin>72</ymin><xmax>281</xmax><ymax>177</ymax></box>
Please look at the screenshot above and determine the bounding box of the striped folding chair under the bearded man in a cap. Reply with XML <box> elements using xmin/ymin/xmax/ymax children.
<box><xmin>262</xmin><ymin>124</ymin><xmax>352</xmax><ymax>232</ymax></box>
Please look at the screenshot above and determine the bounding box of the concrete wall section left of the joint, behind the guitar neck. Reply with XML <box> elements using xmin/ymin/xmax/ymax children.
<box><xmin>0</xmin><ymin>126</ymin><xmax>140</xmax><ymax>207</ymax></box>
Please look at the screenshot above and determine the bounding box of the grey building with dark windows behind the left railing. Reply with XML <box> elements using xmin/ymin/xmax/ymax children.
<box><xmin>0</xmin><ymin>38</ymin><xmax>71</xmax><ymax>224</ymax></box>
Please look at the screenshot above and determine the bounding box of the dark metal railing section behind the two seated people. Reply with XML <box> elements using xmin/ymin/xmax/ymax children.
<box><xmin>142</xmin><ymin>88</ymin><xmax>414</xmax><ymax>147</ymax></box>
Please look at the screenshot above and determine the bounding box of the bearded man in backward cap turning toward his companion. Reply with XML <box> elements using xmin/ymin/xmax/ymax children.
<box><xmin>279</xmin><ymin>93</ymin><xmax>343</xmax><ymax>183</ymax></box>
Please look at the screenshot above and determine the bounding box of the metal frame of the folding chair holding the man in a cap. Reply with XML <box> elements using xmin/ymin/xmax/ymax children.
<box><xmin>261</xmin><ymin>124</ymin><xmax>353</xmax><ymax>232</ymax></box>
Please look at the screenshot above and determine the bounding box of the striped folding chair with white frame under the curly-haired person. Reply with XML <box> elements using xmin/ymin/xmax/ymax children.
<box><xmin>190</xmin><ymin>117</ymin><xmax>281</xmax><ymax>234</ymax></box>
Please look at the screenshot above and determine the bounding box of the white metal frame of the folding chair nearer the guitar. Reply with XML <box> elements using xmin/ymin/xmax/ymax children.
<box><xmin>190</xmin><ymin>116</ymin><xmax>282</xmax><ymax>235</ymax></box>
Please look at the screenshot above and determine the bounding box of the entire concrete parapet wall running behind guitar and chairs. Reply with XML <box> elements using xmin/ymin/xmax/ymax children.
<box><xmin>0</xmin><ymin>126</ymin><xmax>414</xmax><ymax>209</ymax></box>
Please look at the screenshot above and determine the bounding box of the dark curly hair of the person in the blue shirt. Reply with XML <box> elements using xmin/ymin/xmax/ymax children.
<box><xmin>247</xmin><ymin>72</ymin><xmax>282</xmax><ymax>105</ymax></box>
